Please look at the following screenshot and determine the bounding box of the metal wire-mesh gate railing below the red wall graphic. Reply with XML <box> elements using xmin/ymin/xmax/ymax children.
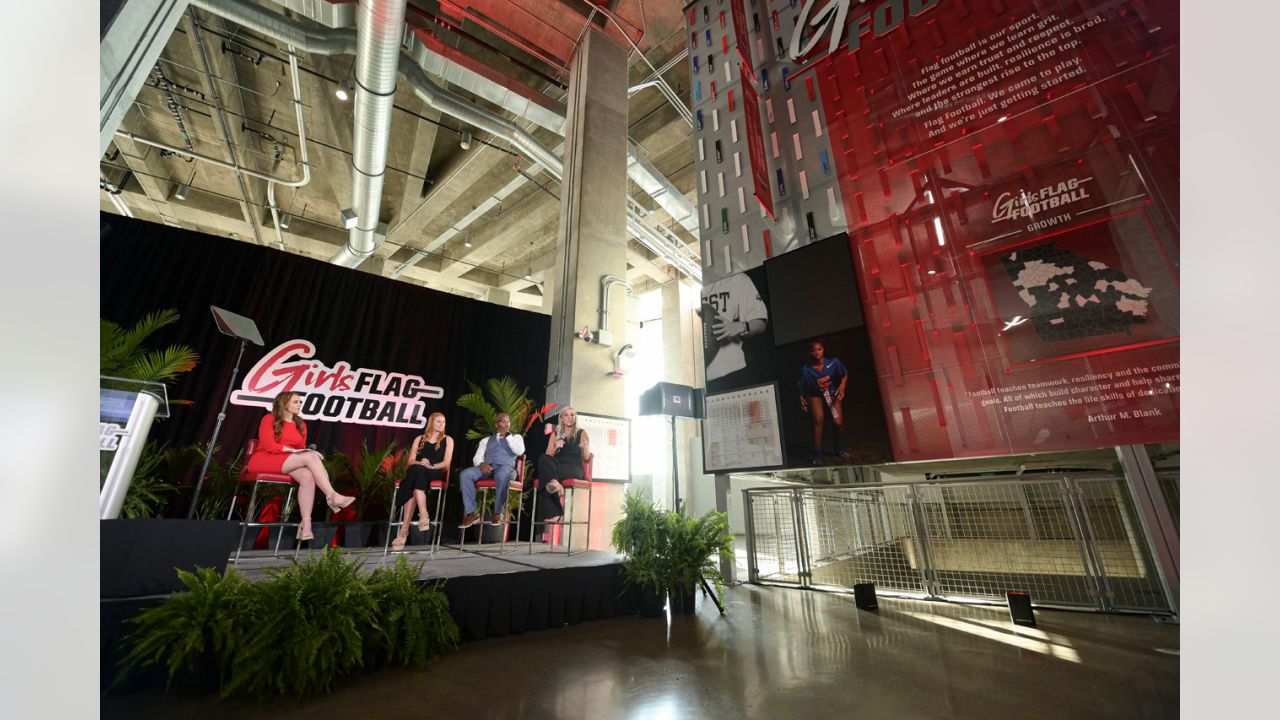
<box><xmin>742</xmin><ymin>475</ymin><xmax>1176</xmax><ymax>612</ymax></box>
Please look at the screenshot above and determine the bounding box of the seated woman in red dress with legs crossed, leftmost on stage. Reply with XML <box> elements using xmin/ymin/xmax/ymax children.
<box><xmin>244</xmin><ymin>392</ymin><xmax>356</xmax><ymax>541</ymax></box>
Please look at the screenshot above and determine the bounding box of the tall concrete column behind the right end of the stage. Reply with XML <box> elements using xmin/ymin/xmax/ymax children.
<box><xmin>547</xmin><ymin>27</ymin><xmax>627</xmax><ymax>548</ymax></box>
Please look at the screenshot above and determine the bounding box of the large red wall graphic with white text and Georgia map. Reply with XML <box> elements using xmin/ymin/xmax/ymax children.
<box><xmin>792</xmin><ymin>0</ymin><xmax>1179</xmax><ymax>461</ymax></box>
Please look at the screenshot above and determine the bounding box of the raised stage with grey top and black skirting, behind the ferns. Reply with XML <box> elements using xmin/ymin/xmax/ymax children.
<box><xmin>100</xmin><ymin>520</ymin><xmax>640</xmax><ymax>692</ymax></box>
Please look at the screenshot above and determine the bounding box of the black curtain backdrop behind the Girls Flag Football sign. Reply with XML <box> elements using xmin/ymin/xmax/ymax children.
<box><xmin>100</xmin><ymin>213</ymin><xmax>550</xmax><ymax>515</ymax></box>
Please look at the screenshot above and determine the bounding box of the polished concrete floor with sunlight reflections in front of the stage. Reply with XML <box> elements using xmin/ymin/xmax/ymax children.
<box><xmin>102</xmin><ymin>585</ymin><xmax>1179</xmax><ymax>720</ymax></box>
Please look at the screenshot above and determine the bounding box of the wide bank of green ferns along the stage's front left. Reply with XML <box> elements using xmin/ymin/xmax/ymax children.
<box><xmin>116</xmin><ymin>548</ymin><xmax>460</xmax><ymax>698</ymax></box>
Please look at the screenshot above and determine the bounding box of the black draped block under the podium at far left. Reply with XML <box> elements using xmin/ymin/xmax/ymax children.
<box><xmin>99</xmin><ymin>519</ymin><xmax>239</xmax><ymax>600</ymax></box>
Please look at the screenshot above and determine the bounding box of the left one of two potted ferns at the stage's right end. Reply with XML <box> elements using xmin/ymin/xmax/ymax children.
<box><xmin>611</xmin><ymin>493</ymin><xmax>667</xmax><ymax>618</ymax></box>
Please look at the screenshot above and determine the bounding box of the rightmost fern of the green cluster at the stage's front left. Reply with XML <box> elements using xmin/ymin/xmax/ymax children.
<box><xmin>365</xmin><ymin>556</ymin><xmax>461</xmax><ymax>670</ymax></box>
